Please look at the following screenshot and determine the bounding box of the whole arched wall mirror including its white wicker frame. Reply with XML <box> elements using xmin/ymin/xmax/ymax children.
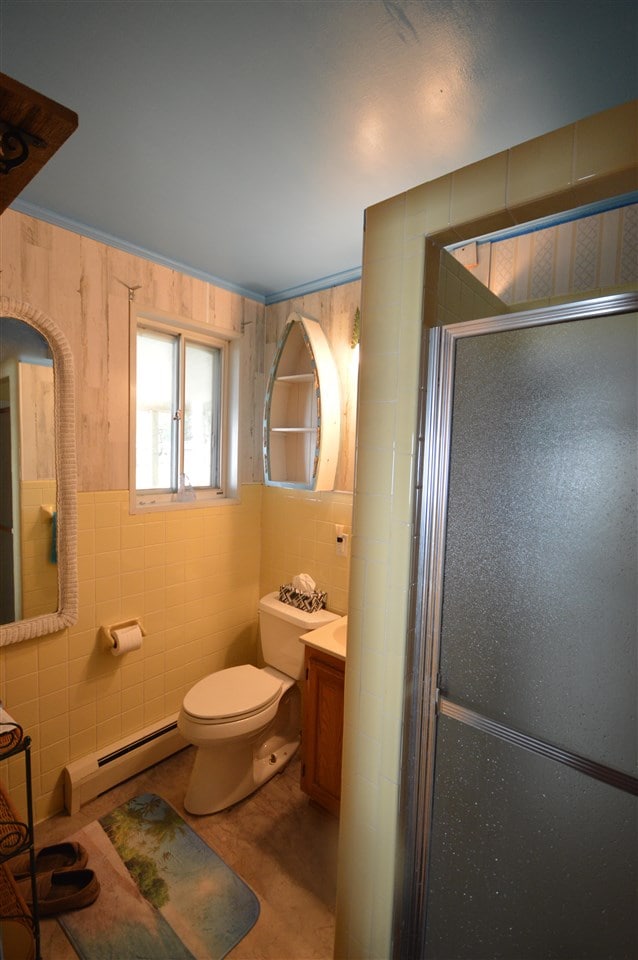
<box><xmin>0</xmin><ymin>297</ymin><xmax>78</xmax><ymax>646</ymax></box>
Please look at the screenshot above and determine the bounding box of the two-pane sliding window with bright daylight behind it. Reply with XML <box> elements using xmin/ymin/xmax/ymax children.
<box><xmin>131</xmin><ymin>312</ymin><xmax>239</xmax><ymax>510</ymax></box>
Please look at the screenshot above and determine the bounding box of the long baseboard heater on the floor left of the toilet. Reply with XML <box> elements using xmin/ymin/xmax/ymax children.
<box><xmin>64</xmin><ymin>714</ymin><xmax>188</xmax><ymax>813</ymax></box>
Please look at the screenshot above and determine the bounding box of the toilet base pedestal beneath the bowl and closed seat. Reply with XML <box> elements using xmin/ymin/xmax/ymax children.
<box><xmin>184</xmin><ymin>686</ymin><xmax>301</xmax><ymax>816</ymax></box>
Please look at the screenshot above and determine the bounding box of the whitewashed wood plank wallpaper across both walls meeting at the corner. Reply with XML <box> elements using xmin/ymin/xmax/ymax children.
<box><xmin>0</xmin><ymin>210</ymin><xmax>360</xmax><ymax>492</ymax></box>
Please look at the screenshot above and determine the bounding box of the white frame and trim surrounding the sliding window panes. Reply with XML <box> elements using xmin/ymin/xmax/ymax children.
<box><xmin>129</xmin><ymin>304</ymin><xmax>240</xmax><ymax>514</ymax></box>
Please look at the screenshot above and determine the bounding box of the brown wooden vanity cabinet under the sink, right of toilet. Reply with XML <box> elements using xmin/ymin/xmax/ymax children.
<box><xmin>301</xmin><ymin>646</ymin><xmax>345</xmax><ymax>816</ymax></box>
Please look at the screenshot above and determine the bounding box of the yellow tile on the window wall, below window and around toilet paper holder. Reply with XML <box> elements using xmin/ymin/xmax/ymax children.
<box><xmin>0</xmin><ymin>484</ymin><xmax>262</xmax><ymax>820</ymax></box>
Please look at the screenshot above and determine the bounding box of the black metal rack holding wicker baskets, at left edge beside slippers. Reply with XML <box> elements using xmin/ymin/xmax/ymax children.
<box><xmin>0</xmin><ymin>709</ymin><xmax>40</xmax><ymax>960</ymax></box>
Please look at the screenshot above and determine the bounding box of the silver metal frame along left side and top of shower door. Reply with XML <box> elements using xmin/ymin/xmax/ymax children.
<box><xmin>393</xmin><ymin>292</ymin><xmax>638</xmax><ymax>960</ymax></box>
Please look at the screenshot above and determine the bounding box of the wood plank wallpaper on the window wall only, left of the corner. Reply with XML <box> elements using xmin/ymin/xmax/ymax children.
<box><xmin>0</xmin><ymin>210</ymin><xmax>264</xmax><ymax>491</ymax></box>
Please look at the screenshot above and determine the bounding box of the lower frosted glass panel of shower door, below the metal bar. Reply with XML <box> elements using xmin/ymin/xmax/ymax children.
<box><xmin>426</xmin><ymin>717</ymin><xmax>638</xmax><ymax>960</ymax></box>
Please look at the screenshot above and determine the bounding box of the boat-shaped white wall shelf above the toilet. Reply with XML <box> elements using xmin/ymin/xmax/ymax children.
<box><xmin>264</xmin><ymin>313</ymin><xmax>341</xmax><ymax>490</ymax></box>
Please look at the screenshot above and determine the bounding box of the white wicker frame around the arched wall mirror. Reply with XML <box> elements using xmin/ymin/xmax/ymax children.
<box><xmin>0</xmin><ymin>296</ymin><xmax>79</xmax><ymax>647</ymax></box>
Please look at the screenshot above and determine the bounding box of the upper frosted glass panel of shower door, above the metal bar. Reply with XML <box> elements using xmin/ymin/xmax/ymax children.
<box><xmin>441</xmin><ymin>314</ymin><xmax>638</xmax><ymax>775</ymax></box>
